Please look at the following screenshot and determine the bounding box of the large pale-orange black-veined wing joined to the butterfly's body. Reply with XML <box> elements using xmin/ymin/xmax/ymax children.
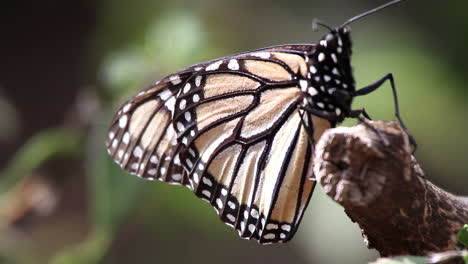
<box><xmin>174</xmin><ymin>46</ymin><xmax>331</xmax><ymax>243</ymax></box>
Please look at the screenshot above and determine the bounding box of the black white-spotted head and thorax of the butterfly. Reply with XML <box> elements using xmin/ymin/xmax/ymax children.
<box><xmin>305</xmin><ymin>27</ymin><xmax>355</xmax><ymax>122</ymax></box>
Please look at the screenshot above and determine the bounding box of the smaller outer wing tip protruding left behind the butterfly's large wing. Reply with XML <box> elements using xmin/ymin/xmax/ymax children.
<box><xmin>107</xmin><ymin>71</ymin><xmax>196</xmax><ymax>184</ymax></box>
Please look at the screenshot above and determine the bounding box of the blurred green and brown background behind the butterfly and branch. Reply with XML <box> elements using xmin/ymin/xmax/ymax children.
<box><xmin>0</xmin><ymin>0</ymin><xmax>468</xmax><ymax>264</ymax></box>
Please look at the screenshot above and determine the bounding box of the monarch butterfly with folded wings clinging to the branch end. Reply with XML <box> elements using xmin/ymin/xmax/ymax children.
<box><xmin>107</xmin><ymin>0</ymin><xmax>401</xmax><ymax>244</ymax></box>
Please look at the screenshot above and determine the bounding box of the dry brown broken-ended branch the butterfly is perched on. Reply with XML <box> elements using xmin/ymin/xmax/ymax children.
<box><xmin>314</xmin><ymin>121</ymin><xmax>468</xmax><ymax>256</ymax></box>
